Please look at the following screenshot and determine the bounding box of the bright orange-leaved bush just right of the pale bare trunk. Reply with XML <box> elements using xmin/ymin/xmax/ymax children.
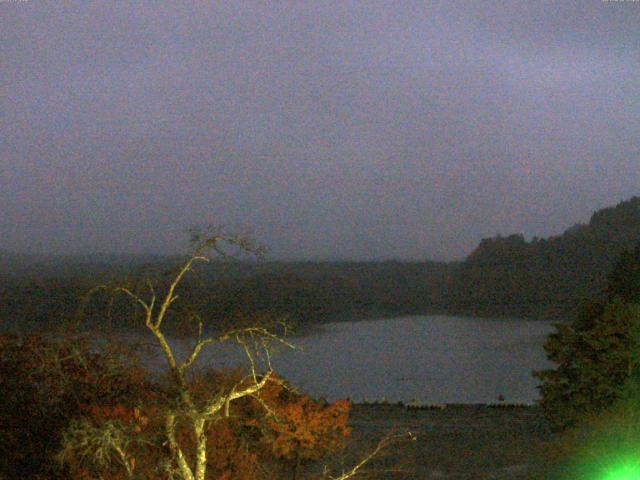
<box><xmin>199</xmin><ymin>375</ymin><xmax>351</xmax><ymax>480</ymax></box>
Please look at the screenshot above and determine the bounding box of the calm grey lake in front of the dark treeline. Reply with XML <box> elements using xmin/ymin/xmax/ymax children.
<box><xmin>152</xmin><ymin>315</ymin><xmax>553</xmax><ymax>404</ymax></box>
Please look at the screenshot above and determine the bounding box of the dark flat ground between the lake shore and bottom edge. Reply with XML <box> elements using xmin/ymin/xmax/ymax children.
<box><xmin>330</xmin><ymin>405</ymin><xmax>549</xmax><ymax>480</ymax></box>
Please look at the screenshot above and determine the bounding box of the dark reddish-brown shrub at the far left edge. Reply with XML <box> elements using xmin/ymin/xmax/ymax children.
<box><xmin>0</xmin><ymin>334</ymin><xmax>146</xmax><ymax>478</ymax></box>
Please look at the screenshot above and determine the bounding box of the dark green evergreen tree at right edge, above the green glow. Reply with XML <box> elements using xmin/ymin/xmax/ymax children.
<box><xmin>534</xmin><ymin>243</ymin><xmax>640</xmax><ymax>430</ymax></box>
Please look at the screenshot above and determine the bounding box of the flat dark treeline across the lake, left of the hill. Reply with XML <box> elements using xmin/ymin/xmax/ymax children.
<box><xmin>0</xmin><ymin>261</ymin><xmax>450</xmax><ymax>334</ymax></box>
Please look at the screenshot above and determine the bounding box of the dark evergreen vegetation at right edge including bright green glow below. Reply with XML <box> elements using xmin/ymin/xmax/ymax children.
<box><xmin>535</xmin><ymin>238</ymin><xmax>640</xmax><ymax>480</ymax></box>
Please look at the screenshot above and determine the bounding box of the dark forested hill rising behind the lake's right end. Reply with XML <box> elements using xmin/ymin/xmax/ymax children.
<box><xmin>445</xmin><ymin>197</ymin><xmax>640</xmax><ymax>317</ymax></box>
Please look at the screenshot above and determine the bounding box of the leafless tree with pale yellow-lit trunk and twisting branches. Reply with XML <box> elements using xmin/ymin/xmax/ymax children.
<box><xmin>100</xmin><ymin>231</ymin><xmax>291</xmax><ymax>480</ymax></box>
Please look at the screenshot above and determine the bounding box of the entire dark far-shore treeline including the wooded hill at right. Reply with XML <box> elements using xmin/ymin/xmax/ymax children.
<box><xmin>0</xmin><ymin>197</ymin><xmax>640</xmax><ymax>324</ymax></box>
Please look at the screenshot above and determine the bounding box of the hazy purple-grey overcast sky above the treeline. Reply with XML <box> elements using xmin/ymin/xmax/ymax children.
<box><xmin>0</xmin><ymin>0</ymin><xmax>640</xmax><ymax>260</ymax></box>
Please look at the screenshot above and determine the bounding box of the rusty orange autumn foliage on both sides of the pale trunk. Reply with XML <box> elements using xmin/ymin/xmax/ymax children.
<box><xmin>0</xmin><ymin>334</ymin><xmax>350</xmax><ymax>480</ymax></box>
